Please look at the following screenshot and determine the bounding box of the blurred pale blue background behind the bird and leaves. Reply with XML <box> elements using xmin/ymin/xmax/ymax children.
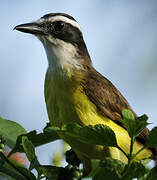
<box><xmin>0</xmin><ymin>0</ymin><xmax>157</xmax><ymax>171</ymax></box>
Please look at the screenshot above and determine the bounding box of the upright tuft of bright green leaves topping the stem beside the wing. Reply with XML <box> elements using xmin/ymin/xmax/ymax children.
<box><xmin>122</xmin><ymin>109</ymin><xmax>148</xmax><ymax>138</ymax></box>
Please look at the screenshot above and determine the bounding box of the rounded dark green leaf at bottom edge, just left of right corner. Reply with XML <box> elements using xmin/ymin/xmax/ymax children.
<box><xmin>122</xmin><ymin>162</ymin><xmax>147</xmax><ymax>180</ymax></box>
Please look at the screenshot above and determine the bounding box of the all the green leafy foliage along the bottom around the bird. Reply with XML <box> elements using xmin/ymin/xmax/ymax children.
<box><xmin>0</xmin><ymin>109</ymin><xmax>157</xmax><ymax>180</ymax></box>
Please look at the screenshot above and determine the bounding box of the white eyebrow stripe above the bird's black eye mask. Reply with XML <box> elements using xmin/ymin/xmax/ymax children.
<box><xmin>49</xmin><ymin>16</ymin><xmax>81</xmax><ymax>31</ymax></box>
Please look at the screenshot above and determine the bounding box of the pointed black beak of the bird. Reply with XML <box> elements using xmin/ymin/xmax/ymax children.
<box><xmin>14</xmin><ymin>22</ymin><xmax>44</xmax><ymax>35</ymax></box>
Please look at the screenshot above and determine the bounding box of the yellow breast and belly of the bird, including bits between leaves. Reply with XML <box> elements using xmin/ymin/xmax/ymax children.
<box><xmin>45</xmin><ymin>68</ymin><xmax>151</xmax><ymax>161</ymax></box>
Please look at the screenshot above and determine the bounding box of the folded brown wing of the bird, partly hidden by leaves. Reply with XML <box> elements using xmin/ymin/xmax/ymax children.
<box><xmin>83</xmin><ymin>66</ymin><xmax>149</xmax><ymax>148</ymax></box>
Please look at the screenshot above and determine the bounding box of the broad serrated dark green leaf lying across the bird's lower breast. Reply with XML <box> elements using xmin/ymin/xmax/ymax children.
<box><xmin>64</xmin><ymin>123</ymin><xmax>118</xmax><ymax>147</ymax></box>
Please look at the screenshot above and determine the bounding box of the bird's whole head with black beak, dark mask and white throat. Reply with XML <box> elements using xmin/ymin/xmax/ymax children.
<box><xmin>14</xmin><ymin>13</ymin><xmax>90</xmax><ymax>71</ymax></box>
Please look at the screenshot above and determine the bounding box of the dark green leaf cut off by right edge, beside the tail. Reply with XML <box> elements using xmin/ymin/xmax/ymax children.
<box><xmin>145</xmin><ymin>127</ymin><xmax>157</xmax><ymax>148</ymax></box>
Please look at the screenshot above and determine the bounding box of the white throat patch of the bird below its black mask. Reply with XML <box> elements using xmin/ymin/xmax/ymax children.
<box><xmin>41</xmin><ymin>38</ymin><xmax>82</xmax><ymax>71</ymax></box>
